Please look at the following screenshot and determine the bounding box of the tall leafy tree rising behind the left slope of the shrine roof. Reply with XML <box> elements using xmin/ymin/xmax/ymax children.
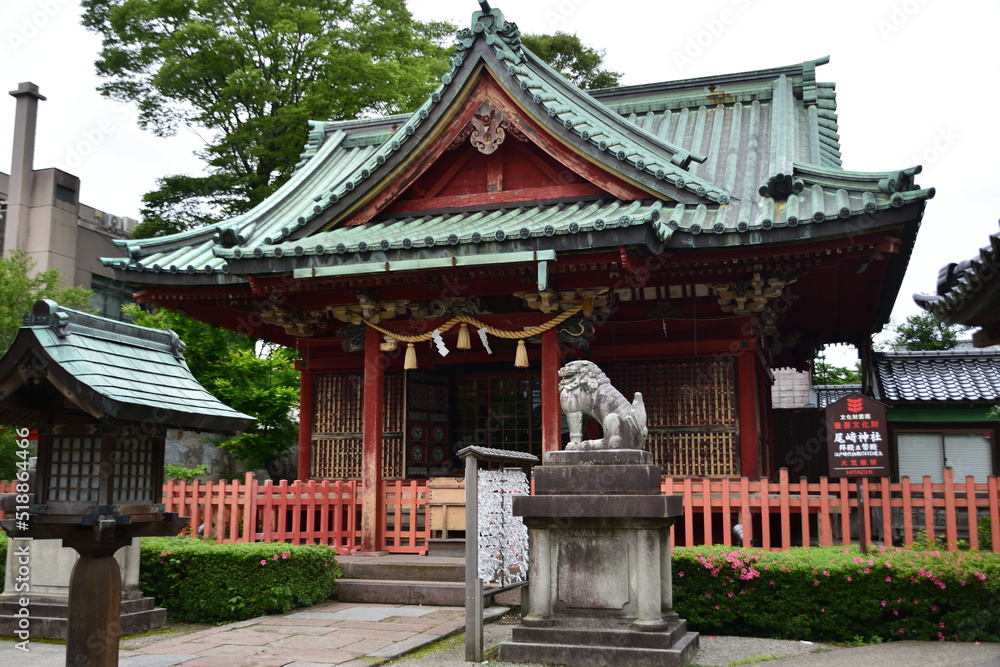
<box><xmin>82</xmin><ymin>0</ymin><xmax>454</xmax><ymax>235</ymax></box>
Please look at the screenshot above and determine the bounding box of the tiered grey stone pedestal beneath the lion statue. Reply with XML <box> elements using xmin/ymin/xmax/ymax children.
<box><xmin>500</xmin><ymin>449</ymin><xmax>698</xmax><ymax>667</ymax></box>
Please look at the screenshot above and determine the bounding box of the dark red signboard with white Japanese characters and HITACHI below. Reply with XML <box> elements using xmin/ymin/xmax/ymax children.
<box><xmin>826</xmin><ymin>394</ymin><xmax>890</xmax><ymax>477</ymax></box>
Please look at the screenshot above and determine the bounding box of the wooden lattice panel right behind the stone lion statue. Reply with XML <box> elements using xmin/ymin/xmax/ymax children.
<box><xmin>605</xmin><ymin>359</ymin><xmax>740</xmax><ymax>477</ymax></box>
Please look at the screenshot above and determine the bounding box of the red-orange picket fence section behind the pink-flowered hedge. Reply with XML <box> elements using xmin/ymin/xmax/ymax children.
<box><xmin>663</xmin><ymin>468</ymin><xmax>1000</xmax><ymax>551</ymax></box>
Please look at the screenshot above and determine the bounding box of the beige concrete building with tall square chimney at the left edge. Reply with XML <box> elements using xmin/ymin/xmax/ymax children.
<box><xmin>0</xmin><ymin>83</ymin><xmax>137</xmax><ymax>318</ymax></box>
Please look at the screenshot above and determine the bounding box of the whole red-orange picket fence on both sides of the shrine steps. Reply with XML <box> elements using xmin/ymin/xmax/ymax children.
<box><xmin>0</xmin><ymin>468</ymin><xmax>1000</xmax><ymax>554</ymax></box>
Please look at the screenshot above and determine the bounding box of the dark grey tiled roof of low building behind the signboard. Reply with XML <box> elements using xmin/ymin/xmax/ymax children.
<box><xmin>875</xmin><ymin>350</ymin><xmax>1000</xmax><ymax>402</ymax></box>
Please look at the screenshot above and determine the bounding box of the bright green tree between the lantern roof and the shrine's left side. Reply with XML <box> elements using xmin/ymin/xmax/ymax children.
<box><xmin>125</xmin><ymin>304</ymin><xmax>299</xmax><ymax>470</ymax></box>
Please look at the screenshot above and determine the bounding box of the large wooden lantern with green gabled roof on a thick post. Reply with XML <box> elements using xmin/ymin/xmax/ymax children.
<box><xmin>0</xmin><ymin>300</ymin><xmax>253</xmax><ymax>666</ymax></box>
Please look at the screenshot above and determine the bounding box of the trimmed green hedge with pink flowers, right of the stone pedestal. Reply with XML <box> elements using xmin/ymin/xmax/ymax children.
<box><xmin>673</xmin><ymin>546</ymin><xmax>1000</xmax><ymax>642</ymax></box>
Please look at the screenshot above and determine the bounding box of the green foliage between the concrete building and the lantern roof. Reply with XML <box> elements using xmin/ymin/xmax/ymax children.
<box><xmin>0</xmin><ymin>250</ymin><xmax>93</xmax><ymax>351</ymax></box>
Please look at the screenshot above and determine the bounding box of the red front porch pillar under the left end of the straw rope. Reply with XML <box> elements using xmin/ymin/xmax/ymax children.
<box><xmin>361</xmin><ymin>327</ymin><xmax>384</xmax><ymax>551</ymax></box>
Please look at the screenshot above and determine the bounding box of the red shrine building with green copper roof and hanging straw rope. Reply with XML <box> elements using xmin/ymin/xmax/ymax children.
<box><xmin>103</xmin><ymin>3</ymin><xmax>934</xmax><ymax>539</ymax></box>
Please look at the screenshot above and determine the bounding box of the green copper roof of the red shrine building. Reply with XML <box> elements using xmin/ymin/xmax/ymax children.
<box><xmin>102</xmin><ymin>2</ymin><xmax>934</xmax><ymax>290</ymax></box>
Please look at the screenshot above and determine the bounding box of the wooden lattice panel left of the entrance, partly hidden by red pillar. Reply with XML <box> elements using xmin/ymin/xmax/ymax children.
<box><xmin>312</xmin><ymin>373</ymin><xmax>403</xmax><ymax>479</ymax></box>
